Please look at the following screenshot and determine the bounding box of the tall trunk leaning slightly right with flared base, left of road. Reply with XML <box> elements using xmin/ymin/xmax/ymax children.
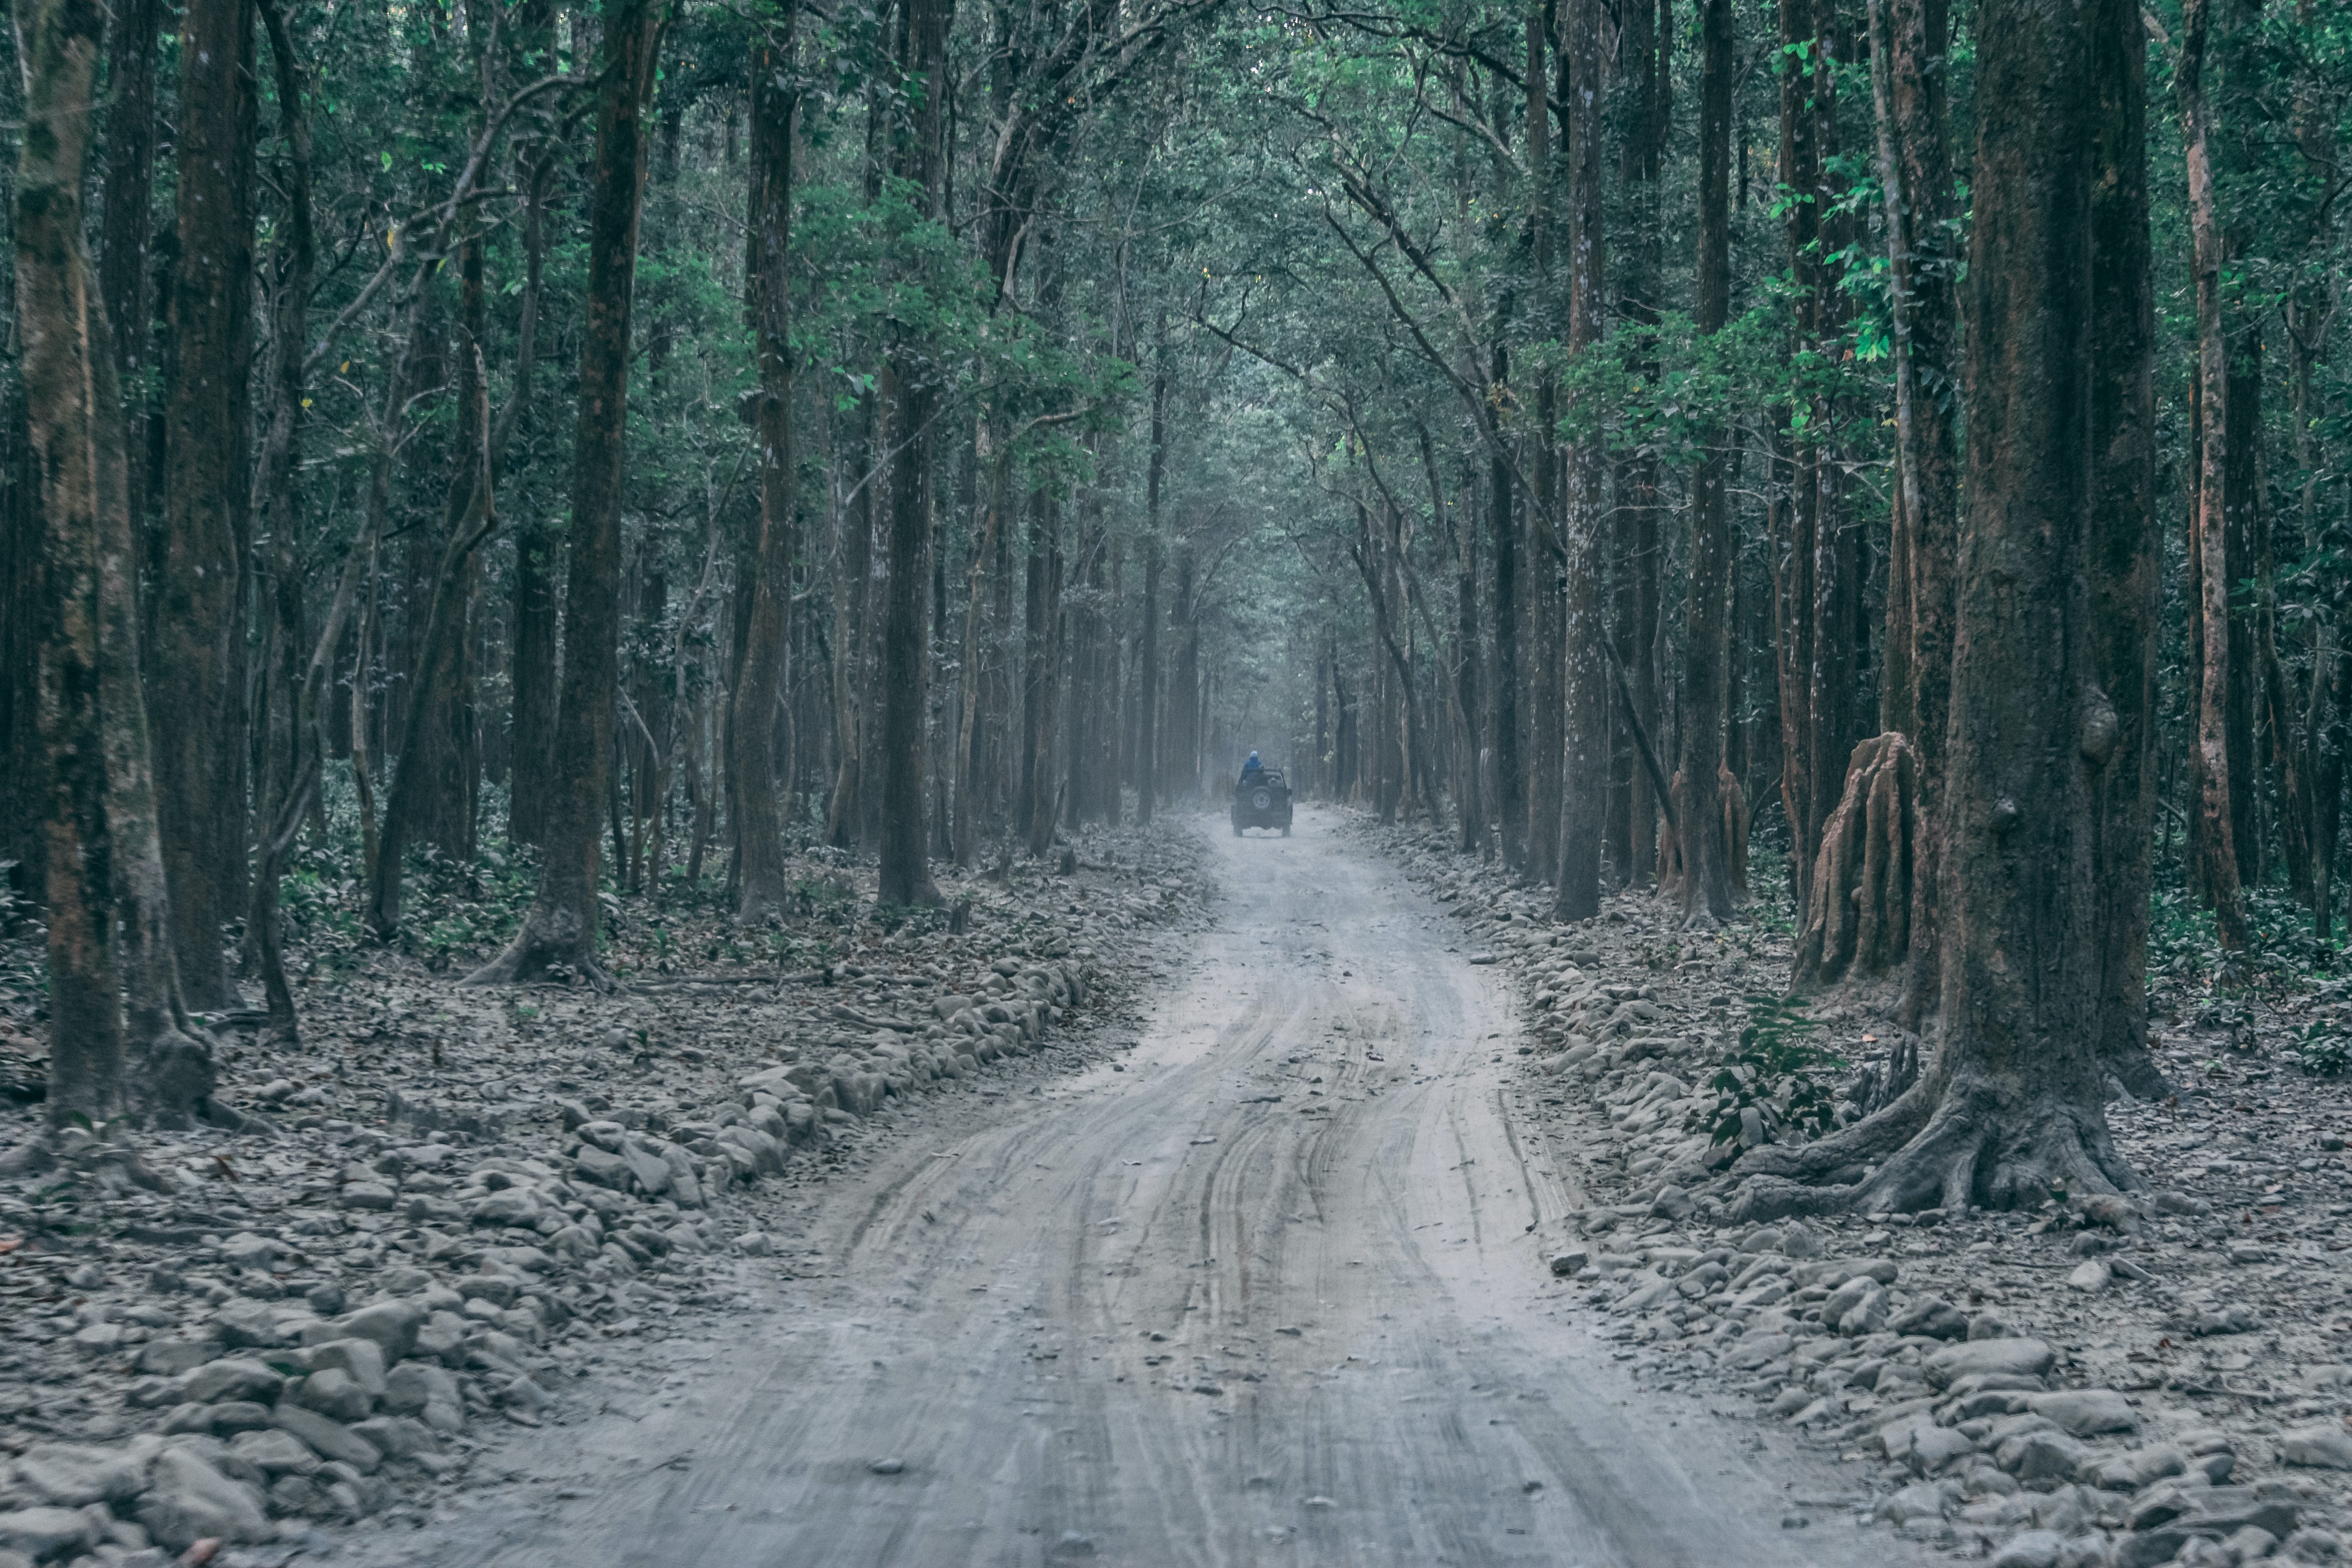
<box><xmin>473</xmin><ymin>0</ymin><xmax>661</xmax><ymax>985</ymax></box>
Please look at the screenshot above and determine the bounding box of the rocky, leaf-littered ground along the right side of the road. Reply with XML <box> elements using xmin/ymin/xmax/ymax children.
<box><xmin>1364</xmin><ymin>825</ymin><xmax>2352</xmax><ymax>1568</ymax></box>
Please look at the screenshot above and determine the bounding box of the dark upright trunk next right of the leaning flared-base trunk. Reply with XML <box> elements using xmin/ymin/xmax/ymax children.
<box><xmin>727</xmin><ymin>21</ymin><xmax>797</xmax><ymax>922</ymax></box>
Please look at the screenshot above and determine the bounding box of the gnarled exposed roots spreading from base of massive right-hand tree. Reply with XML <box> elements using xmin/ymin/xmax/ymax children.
<box><xmin>1731</xmin><ymin>1082</ymin><xmax>2143</xmax><ymax>1225</ymax></box>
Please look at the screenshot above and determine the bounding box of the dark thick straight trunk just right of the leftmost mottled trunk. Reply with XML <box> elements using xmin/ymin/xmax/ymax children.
<box><xmin>148</xmin><ymin>0</ymin><xmax>256</xmax><ymax>1011</ymax></box>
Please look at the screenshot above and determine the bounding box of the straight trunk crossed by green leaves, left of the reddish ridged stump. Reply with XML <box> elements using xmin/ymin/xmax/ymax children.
<box><xmin>1675</xmin><ymin>0</ymin><xmax>1736</xmax><ymax>922</ymax></box>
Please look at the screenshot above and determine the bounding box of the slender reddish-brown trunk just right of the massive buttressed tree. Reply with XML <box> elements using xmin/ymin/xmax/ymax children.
<box><xmin>2173</xmin><ymin>0</ymin><xmax>2246</xmax><ymax>952</ymax></box>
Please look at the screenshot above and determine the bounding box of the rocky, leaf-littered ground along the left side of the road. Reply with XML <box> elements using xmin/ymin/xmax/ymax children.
<box><xmin>0</xmin><ymin>832</ymin><xmax>1204</xmax><ymax>1568</ymax></box>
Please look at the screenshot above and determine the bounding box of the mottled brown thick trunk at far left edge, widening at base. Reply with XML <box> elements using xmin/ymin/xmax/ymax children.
<box><xmin>16</xmin><ymin>0</ymin><xmax>216</xmax><ymax>1126</ymax></box>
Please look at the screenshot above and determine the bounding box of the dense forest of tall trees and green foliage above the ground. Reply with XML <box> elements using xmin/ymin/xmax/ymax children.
<box><xmin>0</xmin><ymin>0</ymin><xmax>2352</xmax><ymax>1215</ymax></box>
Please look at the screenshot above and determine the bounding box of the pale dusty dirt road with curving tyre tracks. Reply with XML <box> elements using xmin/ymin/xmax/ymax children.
<box><xmin>353</xmin><ymin>813</ymin><xmax>1889</xmax><ymax>1568</ymax></box>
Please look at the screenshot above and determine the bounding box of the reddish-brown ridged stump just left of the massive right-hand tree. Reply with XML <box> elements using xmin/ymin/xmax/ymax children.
<box><xmin>1795</xmin><ymin>731</ymin><xmax>1922</xmax><ymax>992</ymax></box>
